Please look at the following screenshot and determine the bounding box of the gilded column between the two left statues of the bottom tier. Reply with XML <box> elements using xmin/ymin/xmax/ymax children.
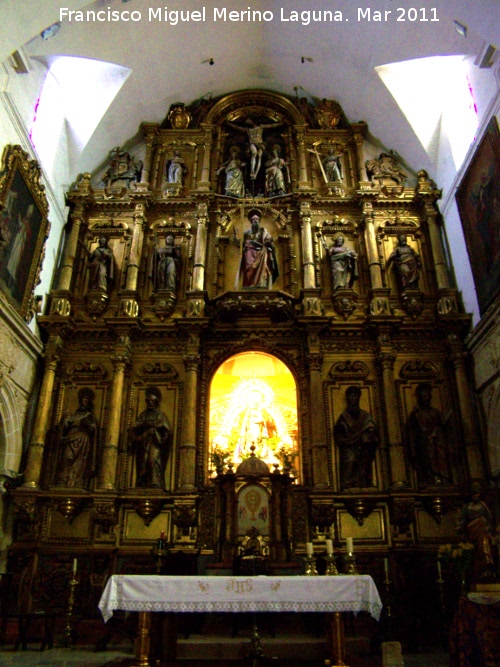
<box><xmin>99</xmin><ymin>338</ymin><xmax>129</xmax><ymax>491</ymax></box>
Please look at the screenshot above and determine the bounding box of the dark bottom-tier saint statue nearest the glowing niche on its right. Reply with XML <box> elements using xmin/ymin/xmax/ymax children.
<box><xmin>333</xmin><ymin>385</ymin><xmax>380</xmax><ymax>489</ymax></box>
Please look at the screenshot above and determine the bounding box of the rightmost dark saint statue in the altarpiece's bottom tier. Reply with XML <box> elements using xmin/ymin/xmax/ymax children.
<box><xmin>408</xmin><ymin>382</ymin><xmax>451</xmax><ymax>486</ymax></box>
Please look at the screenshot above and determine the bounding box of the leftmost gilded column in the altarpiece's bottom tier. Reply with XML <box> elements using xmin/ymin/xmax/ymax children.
<box><xmin>23</xmin><ymin>337</ymin><xmax>62</xmax><ymax>489</ymax></box>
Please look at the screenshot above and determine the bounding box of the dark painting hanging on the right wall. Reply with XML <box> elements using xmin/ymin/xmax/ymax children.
<box><xmin>456</xmin><ymin>116</ymin><xmax>500</xmax><ymax>314</ymax></box>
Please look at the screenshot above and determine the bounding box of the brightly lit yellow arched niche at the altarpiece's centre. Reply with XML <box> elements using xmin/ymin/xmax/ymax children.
<box><xmin>209</xmin><ymin>351</ymin><xmax>300</xmax><ymax>480</ymax></box>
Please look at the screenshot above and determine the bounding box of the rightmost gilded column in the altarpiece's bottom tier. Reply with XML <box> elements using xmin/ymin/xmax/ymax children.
<box><xmin>449</xmin><ymin>334</ymin><xmax>484</xmax><ymax>479</ymax></box>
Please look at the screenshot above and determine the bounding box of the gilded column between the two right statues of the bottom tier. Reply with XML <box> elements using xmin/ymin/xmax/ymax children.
<box><xmin>377</xmin><ymin>342</ymin><xmax>408</xmax><ymax>489</ymax></box>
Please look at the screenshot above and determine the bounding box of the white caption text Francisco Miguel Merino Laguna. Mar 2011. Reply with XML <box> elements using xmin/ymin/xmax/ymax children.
<box><xmin>59</xmin><ymin>7</ymin><xmax>439</xmax><ymax>26</ymax></box>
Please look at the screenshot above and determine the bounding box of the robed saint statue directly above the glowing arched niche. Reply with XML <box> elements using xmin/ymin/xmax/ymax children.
<box><xmin>233</xmin><ymin>209</ymin><xmax>279</xmax><ymax>289</ymax></box>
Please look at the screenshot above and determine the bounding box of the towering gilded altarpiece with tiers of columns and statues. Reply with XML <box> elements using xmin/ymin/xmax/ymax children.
<box><xmin>7</xmin><ymin>90</ymin><xmax>487</xmax><ymax>640</ymax></box>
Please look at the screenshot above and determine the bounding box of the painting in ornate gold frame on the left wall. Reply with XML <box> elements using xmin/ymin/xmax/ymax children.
<box><xmin>0</xmin><ymin>144</ymin><xmax>49</xmax><ymax>321</ymax></box>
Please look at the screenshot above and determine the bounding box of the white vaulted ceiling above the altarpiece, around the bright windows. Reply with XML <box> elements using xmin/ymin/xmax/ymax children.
<box><xmin>0</xmin><ymin>0</ymin><xmax>500</xmax><ymax>320</ymax></box>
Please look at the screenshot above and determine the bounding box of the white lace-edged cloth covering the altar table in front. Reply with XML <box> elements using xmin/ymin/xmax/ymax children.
<box><xmin>99</xmin><ymin>574</ymin><xmax>382</xmax><ymax>621</ymax></box>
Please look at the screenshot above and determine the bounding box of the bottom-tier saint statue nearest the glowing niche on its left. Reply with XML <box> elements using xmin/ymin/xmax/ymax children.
<box><xmin>132</xmin><ymin>387</ymin><xmax>172</xmax><ymax>489</ymax></box>
